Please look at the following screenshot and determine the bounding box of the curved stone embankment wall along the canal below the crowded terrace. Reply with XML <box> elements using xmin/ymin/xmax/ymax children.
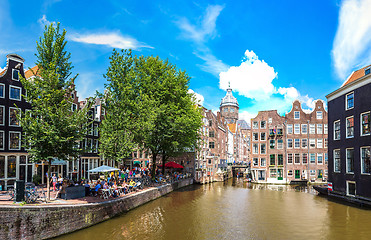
<box><xmin>0</xmin><ymin>178</ymin><xmax>193</xmax><ymax>239</ymax></box>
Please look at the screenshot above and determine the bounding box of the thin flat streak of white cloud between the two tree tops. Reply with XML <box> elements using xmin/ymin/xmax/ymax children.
<box><xmin>69</xmin><ymin>33</ymin><xmax>153</xmax><ymax>49</ymax></box>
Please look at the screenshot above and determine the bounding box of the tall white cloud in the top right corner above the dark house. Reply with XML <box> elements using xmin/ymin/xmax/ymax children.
<box><xmin>332</xmin><ymin>0</ymin><xmax>371</xmax><ymax>80</ymax></box>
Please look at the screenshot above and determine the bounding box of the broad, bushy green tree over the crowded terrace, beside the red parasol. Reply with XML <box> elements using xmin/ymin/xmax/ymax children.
<box><xmin>101</xmin><ymin>51</ymin><xmax>202</xmax><ymax>176</ymax></box>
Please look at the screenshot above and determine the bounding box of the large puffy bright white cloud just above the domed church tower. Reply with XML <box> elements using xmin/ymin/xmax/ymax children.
<box><xmin>219</xmin><ymin>50</ymin><xmax>277</xmax><ymax>100</ymax></box>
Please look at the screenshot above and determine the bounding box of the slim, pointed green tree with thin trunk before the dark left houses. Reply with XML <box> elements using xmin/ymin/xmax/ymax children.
<box><xmin>18</xmin><ymin>24</ymin><xmax>92</xmax><ymax>199</ymax></box>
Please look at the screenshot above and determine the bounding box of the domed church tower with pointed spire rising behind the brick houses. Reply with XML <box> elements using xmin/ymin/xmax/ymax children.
<box><xmin>219</xmin><ymin>85</ymin><xmax>239</xmax><ymax>124</ymax></box>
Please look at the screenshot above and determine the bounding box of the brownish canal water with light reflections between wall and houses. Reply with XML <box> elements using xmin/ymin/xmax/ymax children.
<box><xmin>58</xmin><ymin>179</ymin><xmax>371</xmax><ymax>240</ymax></box>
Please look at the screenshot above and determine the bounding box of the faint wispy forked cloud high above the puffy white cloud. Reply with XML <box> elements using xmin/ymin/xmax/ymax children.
<box><xmin>176</xmin><ymin>5</ymin><xmax>228</xmax><ymax>76</ymax></box>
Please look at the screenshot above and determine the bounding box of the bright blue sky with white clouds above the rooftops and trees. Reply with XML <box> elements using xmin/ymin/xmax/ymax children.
<box><xmin>0</xmin><ymin>0</ymin><xmax>371</xmax><ymax>120</ymax></box>
